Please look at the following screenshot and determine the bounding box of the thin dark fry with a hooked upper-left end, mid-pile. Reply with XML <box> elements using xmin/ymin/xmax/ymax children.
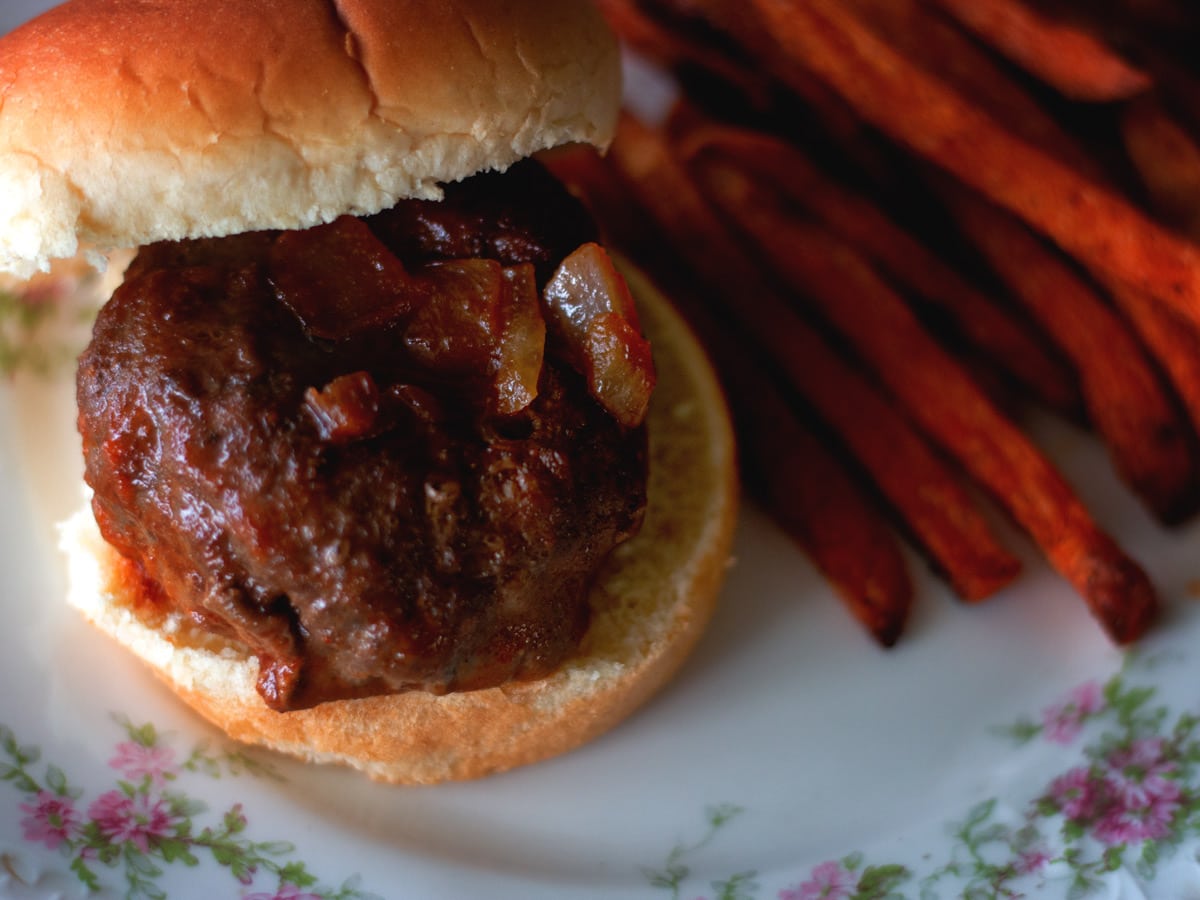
<box><xmin>680</xmin><ymin>124</ymin><xmax>1082</xmax><ymax>419</ymax></box>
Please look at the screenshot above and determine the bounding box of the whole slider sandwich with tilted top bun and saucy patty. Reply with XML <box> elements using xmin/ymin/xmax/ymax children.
<box><xmin>0</xmin><ymin>0</ymin><xmax>736</xmax><ymax>784</ymax></box>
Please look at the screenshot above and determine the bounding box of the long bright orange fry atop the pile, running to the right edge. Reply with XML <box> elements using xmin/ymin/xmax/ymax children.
<box><xmin>752</xmin><ymin>0</ymin><xmax>1200</xmax><ymax>336</ymax></box>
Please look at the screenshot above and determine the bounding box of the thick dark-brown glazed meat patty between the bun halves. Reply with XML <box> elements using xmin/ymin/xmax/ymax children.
<box><xmin>78</xmin><ymin>163</ymin><xmax>646</xmax><ymax>710</ymax></box>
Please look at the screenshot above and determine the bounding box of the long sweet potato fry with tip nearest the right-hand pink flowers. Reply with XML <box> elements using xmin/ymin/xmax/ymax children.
<box><xmin>706</xmin><ymin>160</ymin><xmax>1157</xmax><ymax>643</ymax></box>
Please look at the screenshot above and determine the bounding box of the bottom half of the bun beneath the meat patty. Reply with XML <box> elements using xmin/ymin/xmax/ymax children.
<box><xmin>64</xmin><ymin>264</ymin><xmax>737</xmax><ymax>784</ymax></box>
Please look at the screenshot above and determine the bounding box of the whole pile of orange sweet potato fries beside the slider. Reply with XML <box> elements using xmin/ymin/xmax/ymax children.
<box><xmin>548</xmin><ymin>0</ymin><xmax>1200</xmax><ymax>646</ymax></box>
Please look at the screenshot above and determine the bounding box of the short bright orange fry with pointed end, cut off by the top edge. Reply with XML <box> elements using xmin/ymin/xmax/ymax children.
<box><xmin>921</xmin><ymin>0</ymin><xmax>1152</xmax><ymax>103</ymax></box>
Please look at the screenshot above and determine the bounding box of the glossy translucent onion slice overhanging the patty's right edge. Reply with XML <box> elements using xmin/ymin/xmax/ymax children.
<box><xmin>542</xmin><ymin>244</ymin><xmax>655</xmax><ymax>427</ymax></box>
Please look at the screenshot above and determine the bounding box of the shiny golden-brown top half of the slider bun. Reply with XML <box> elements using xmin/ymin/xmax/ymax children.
<box><xmin>0</xmin><ymin>0</ymin><xmax>620</xmax><ymax>277</ymax></box>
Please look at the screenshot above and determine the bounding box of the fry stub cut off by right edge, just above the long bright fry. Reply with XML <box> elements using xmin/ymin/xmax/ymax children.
<box><xmin>1121</xmin><ymin>96</ymin><xmax>1200</xmax><ymax>239</ymax></box>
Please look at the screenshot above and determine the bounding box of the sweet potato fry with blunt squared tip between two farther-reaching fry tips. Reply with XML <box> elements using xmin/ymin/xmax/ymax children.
<box><xmin>610</xmin><ymin>118</ymin><xmax>1020</xmax><ymax>600</ymax></box>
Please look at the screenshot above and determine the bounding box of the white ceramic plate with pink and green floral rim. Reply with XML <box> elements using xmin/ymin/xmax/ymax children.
<box><xmin>7</xmin><ymin>0</ymin><xmax>1200</xmax><ymax>900</ymax></box>
